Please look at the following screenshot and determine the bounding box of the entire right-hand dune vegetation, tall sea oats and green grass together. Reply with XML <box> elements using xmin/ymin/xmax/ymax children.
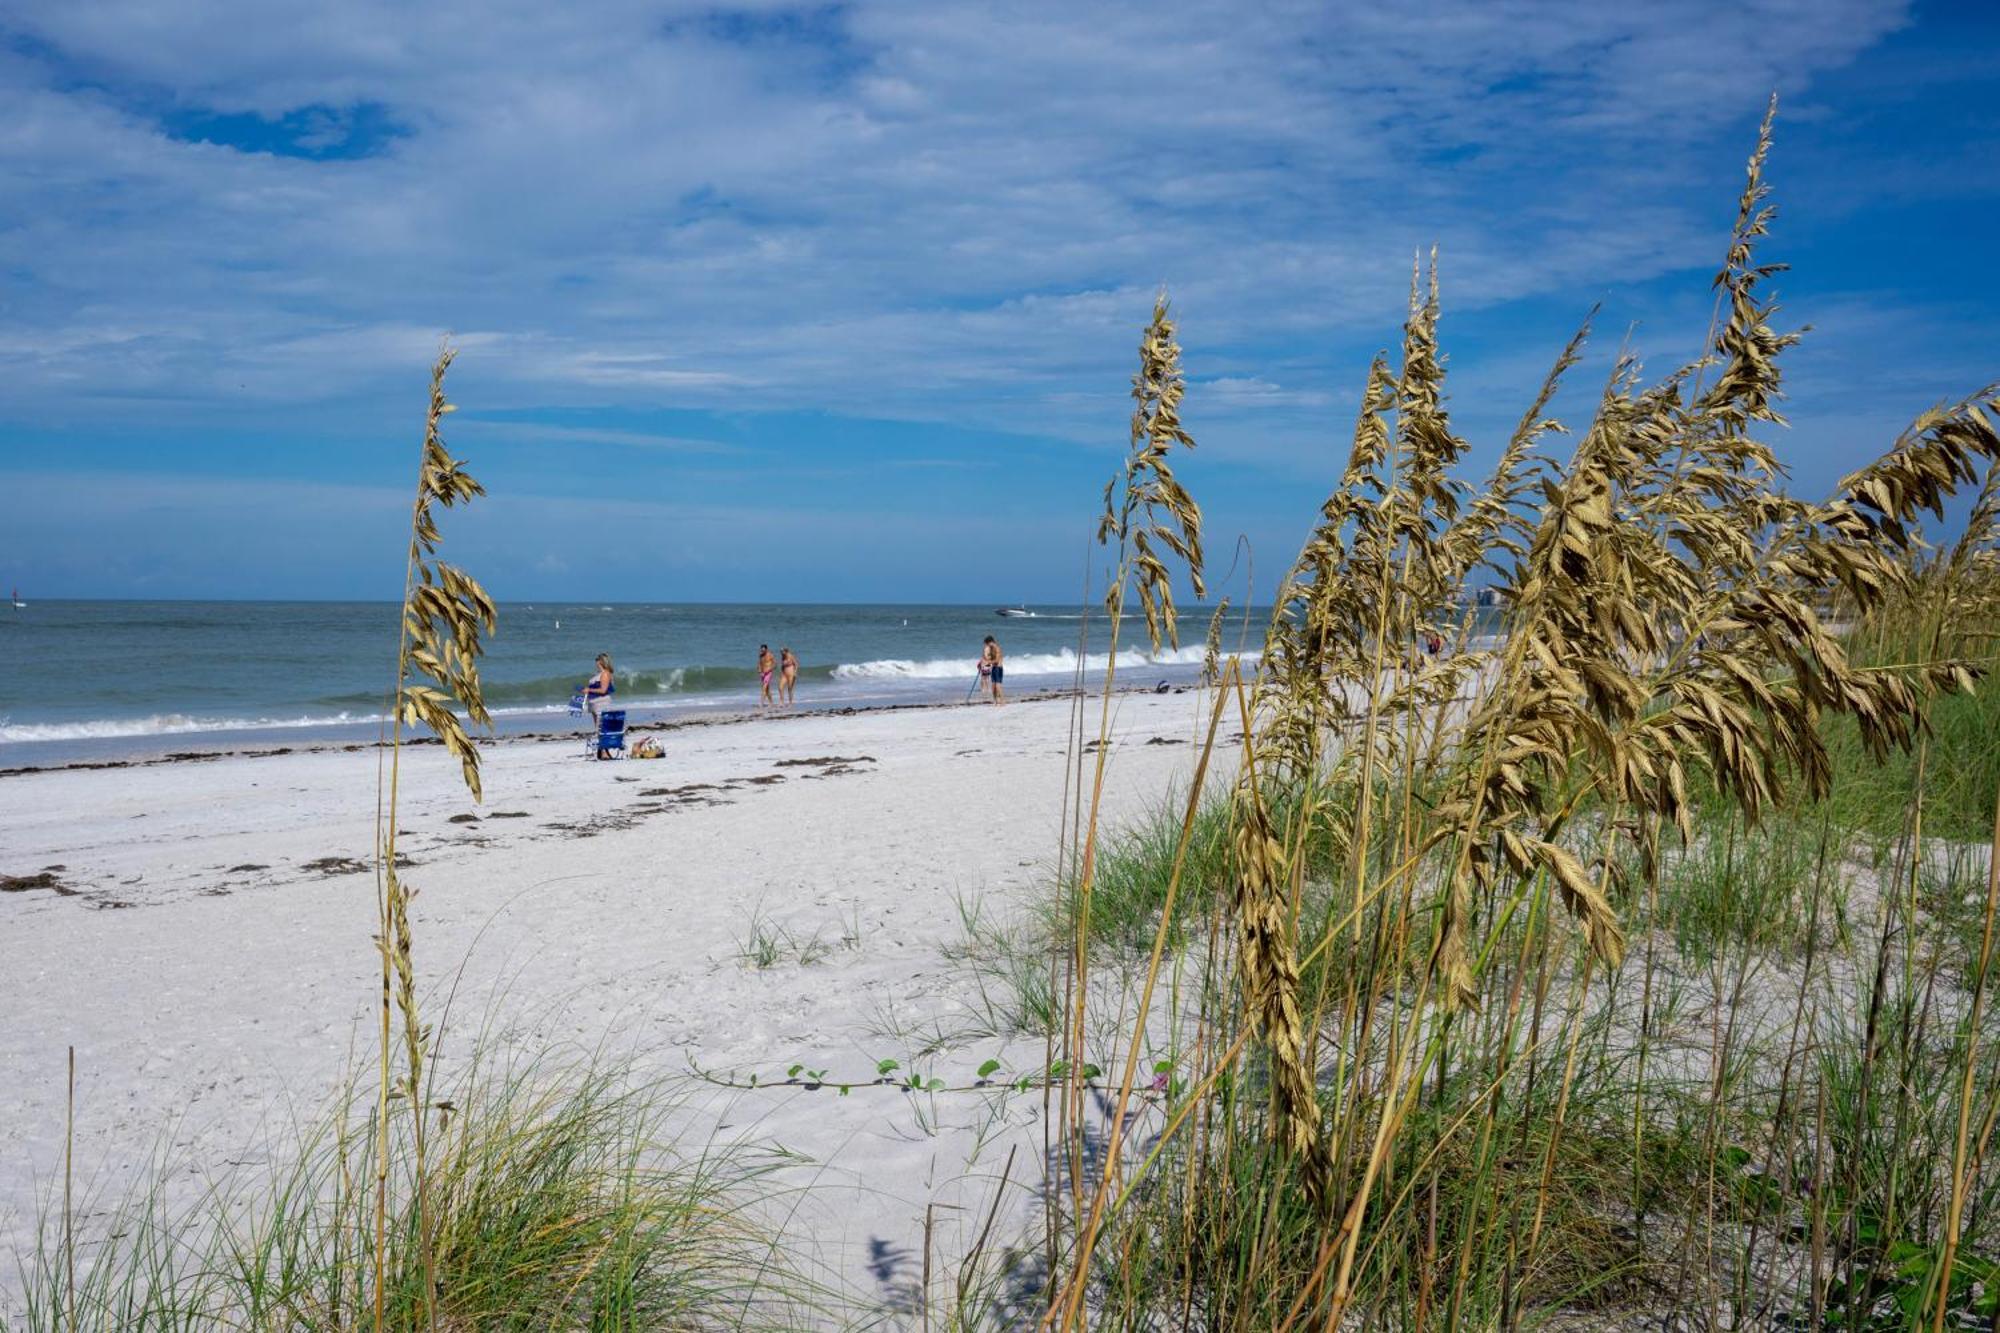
<box><xmin>1042</xmin><ymin>101</ymin><xmax>2000</xmax><ymax>1333</ymax></box>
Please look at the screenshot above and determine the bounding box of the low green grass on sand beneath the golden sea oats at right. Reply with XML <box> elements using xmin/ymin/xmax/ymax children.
<box><xmin>1024</xmin><ymin>704</ymin><xmax>2000</xmax><ymax>1329</ymax></box>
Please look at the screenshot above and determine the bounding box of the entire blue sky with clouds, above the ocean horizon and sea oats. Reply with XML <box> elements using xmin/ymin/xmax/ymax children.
<box><xmin>0</xmin><ymin>0</ymin><xmax>2000</xmax><ymax>600</ymax></box>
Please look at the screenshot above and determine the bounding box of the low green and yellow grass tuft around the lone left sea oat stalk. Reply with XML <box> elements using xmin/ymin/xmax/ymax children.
<box><xmin>14</xmin><ymin>1055</ymin><xmax>806</xmax><ymax>1333</ymax></box>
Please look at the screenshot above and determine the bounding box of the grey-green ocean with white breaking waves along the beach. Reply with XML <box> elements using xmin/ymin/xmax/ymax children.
<box><xmin>0</xmin><ymin>600</ymin><xmax>1232</xmax><ymax>769</ymax></box>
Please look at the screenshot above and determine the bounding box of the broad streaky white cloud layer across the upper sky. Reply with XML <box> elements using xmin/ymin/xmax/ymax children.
<box><xmin>0</xmin><ymin>0</ymin><xmax>1952</xmax><ymax>474</ymax></box>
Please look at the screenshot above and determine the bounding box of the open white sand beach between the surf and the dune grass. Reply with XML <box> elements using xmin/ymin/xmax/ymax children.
<box><xmin>0</xmin><ymin>693</ymin><xmax>1198</xmax><ymax>1313</ymax></box>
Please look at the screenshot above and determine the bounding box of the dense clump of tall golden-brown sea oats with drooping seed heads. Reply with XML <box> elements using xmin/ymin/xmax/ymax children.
<box><xmin>1058</xmin><ymin>102</ymin><xmax>2000</xmax><ymax>1327</ymax></box>
